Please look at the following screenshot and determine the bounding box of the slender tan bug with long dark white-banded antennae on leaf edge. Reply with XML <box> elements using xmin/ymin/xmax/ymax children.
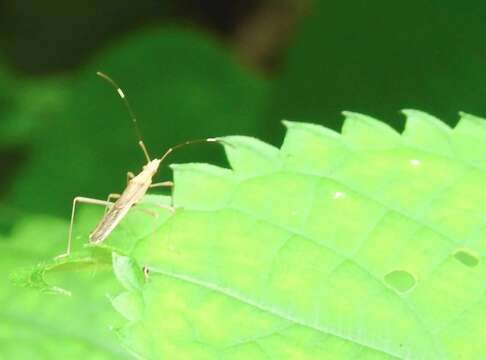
<box><xmin>56</xmin><ymin>72</ymin><xmax>223</xmax><ymax>258</ymax></box>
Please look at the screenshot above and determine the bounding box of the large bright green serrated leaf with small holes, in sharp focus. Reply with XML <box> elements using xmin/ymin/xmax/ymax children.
<box><xmin>105</xmin><ymin>111</ymin><xmax>486</xmax><ymax>359</ymax></box>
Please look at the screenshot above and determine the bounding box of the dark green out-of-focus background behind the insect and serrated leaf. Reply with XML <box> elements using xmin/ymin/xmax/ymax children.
<box><xmin>0</xmin><ymin>0</ymin><xmax>486</xmax><ymax>358</ymax></box>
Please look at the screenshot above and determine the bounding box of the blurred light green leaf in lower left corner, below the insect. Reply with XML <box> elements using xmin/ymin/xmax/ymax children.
<box><xmin>0</xmin><ymin>210</ymin><xmax>130</xmax><ymax>360</ymax></box>
